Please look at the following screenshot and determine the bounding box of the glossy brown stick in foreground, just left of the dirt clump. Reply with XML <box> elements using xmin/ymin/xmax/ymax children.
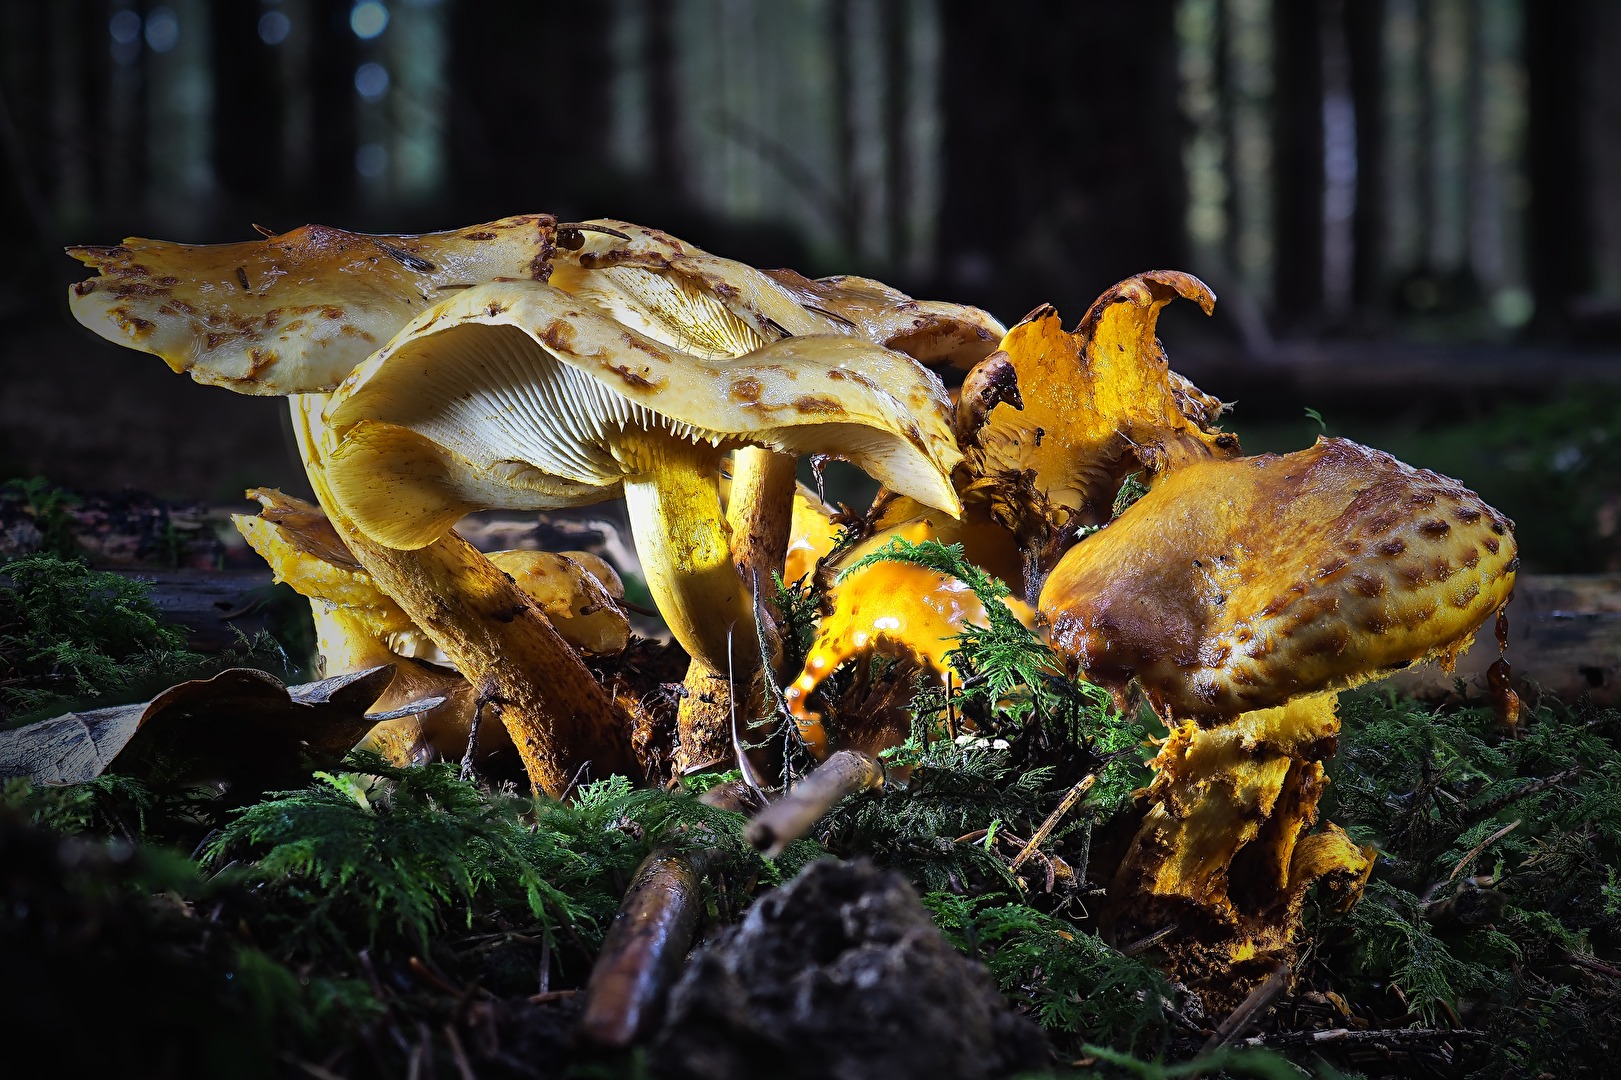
<box><xmin>579</xmin><ymin>845</ymin><xmax>716</xmax><ymax>1048</ymax></box>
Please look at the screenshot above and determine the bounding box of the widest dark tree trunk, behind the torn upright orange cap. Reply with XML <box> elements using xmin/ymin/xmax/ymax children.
<box><xmin>934</xmin><ymin>0</ymin><xmax>1185</xmax><ymax>321</ymax></box>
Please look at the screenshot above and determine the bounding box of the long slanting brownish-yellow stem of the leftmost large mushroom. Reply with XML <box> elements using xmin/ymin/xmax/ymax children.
<box><xmin>289</xmin><ymin>394</ymin><xmax>634</xmax><ymax>798</ymax></box>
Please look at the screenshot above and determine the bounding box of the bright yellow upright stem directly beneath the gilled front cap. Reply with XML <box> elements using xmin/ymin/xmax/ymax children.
<box><xmin>618</xmin><ymin>431</ymin><xmax>760</xmax><ymax>678</ymax></box>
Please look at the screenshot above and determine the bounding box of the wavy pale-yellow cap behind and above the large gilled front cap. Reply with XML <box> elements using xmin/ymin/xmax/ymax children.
<box><xmin>551</xmin><ymin>219</ymin><xmax>1002</xmax><ymax>366</ymax></box>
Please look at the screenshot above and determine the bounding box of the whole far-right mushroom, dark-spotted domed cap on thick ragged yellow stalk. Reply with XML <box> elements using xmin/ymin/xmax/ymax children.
<box><xmin>1041</xmin><ymin>439</ymin><xmax>1517</xmax><ymax>1004</ymax></box>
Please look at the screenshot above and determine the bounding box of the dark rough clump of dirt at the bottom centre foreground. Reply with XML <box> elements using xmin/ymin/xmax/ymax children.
<box><xmin>652</xmin><ymin>859</ymin><xmax>1047</xmax><ymax>1080</ymax></box>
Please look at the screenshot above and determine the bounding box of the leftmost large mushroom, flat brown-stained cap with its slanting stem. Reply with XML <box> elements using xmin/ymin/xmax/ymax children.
<box><xmin>70</xmin><ymin>216</ymin><xmax>631</xmax><ymax>793</ymax></box>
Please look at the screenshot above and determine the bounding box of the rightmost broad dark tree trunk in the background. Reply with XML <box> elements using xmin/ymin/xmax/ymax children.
<box><xmin>1525</xmin><ymin>0</ymin><xmax>1592</xmax><ymax>332</ymax></box>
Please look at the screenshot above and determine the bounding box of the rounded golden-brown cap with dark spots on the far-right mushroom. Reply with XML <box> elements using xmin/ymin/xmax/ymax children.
<box><xmin>1041</xmin><ymin>439</ymin><xmax>1517</xmax><ymax>722</ymax></box>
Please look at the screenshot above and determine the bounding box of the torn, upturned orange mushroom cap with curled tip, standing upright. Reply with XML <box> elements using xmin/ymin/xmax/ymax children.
<box><xmin>963</xmin><ymin>271</ymin><xmax>1238</xmax><ymax>535</ymax></box>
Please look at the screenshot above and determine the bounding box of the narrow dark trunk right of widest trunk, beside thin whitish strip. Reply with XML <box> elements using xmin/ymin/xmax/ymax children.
<box><xmin>1272</xmin><ymin>0</ymin><xmax>1323</xmax><ymax>331</ymax></box>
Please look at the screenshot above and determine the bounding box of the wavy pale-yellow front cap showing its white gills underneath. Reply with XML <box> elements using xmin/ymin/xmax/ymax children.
<box><xmin>326</xmin><ymin>282</ymin><xmax>961</xmax><ymax>548</ymax></box>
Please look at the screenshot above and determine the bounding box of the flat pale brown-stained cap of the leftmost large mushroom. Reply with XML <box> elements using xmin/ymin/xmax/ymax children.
<box><xmin>68</xmin><ymin>214</ymin><xmax>556</xmax><ymax>396</ymax></box>
